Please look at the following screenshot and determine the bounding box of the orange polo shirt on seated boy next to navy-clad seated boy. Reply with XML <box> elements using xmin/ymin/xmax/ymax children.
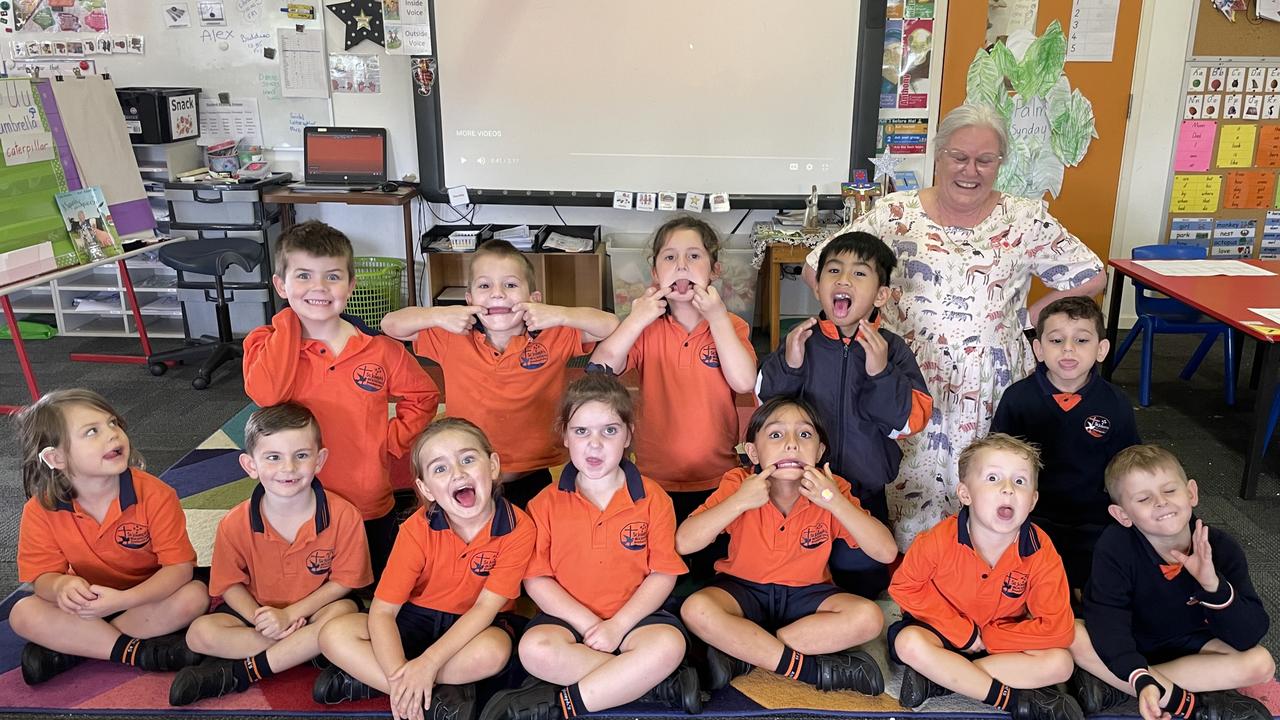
<box><xmin>888</xmin><ymin>507</ymin><xmax>1075</xmax><ymax>652</ymax></box>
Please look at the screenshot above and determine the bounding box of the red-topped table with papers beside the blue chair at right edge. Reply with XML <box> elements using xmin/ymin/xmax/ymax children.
<box><xmin>1102</xmin><ymin>259</ymin><xmax>1280</xmax><ymax>500</ymax></box>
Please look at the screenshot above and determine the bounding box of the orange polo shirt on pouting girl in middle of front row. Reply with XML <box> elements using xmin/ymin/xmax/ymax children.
<box><xmin>526</xmin><ymin>460</ymin><xmax>689</xmax><ymax>620</ymax></box>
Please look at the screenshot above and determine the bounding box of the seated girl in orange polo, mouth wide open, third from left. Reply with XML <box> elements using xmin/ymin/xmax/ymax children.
<box><xmin>312</xmin><ymin>418</ymin><xmax>536</xmax><ymax>720</ymax></box>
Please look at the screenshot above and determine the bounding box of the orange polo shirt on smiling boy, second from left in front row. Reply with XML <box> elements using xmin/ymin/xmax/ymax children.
<box><xmin>209</xmin><ymin>479</ymin><xmax>374</xmax><ymax>607</ymax></box>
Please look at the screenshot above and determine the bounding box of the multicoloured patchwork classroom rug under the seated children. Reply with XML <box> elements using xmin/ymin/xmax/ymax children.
<box><xmin>0</xmin><ymin>406</ymin><xmax>1280</xmax><ymax>719</ymax></box>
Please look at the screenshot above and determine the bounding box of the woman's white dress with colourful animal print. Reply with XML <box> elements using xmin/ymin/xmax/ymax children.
<box><xmin>808</xmin><ymin>191</ymin><xmax>1102</xmax><ymax>543</ymax></box>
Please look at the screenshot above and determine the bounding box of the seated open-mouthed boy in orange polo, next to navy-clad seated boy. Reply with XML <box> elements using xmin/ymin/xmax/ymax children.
<box><xmin>888</xmin><ymin>433</ymin><xmax>1084</xmax><ymax>720</ymax></box>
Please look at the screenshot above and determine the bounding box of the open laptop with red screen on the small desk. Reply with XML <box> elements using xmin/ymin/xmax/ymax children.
<box><xmin>289</xmin><ymin>127</ymin><xmax>387</xmax><ymax>192</ymax></box>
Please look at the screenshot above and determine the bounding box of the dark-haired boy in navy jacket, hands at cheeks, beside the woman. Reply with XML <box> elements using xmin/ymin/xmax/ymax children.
<box><xmin>759</xmin><ymin>232</ymin><xmax>933</xmax><ymax>597</ymax></box>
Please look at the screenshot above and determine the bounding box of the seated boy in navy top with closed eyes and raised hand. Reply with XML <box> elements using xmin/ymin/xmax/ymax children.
<box><xmin>1071</xmin><ymin>445</ymin><xmax>1275</xmax><ymax>719</ymax></box>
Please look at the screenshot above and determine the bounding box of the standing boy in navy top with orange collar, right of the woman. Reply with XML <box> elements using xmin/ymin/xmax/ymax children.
<box><xmin>991</xmin><ymin>297</ymin><xmax>1142</xmax><ymax>591</ymax></box>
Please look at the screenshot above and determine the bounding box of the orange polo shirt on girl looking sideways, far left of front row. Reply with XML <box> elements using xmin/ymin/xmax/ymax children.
<box><xmin>18</xmin><ymin>468</ymin><xmax>196</xmax><ymax>591</ymax></box>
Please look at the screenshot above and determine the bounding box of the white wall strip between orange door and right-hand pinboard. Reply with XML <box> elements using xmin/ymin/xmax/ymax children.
<box><xmin>1105</xmin><ymin>0</ymin><xmax>1203</xmax><ymax>327</ymax></box>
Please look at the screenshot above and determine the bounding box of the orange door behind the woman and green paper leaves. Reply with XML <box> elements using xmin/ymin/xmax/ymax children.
<box><xmin>940</xmin><ymin>0</ymin><xmax>1155</xmax><ymax>292</ymax></box>
